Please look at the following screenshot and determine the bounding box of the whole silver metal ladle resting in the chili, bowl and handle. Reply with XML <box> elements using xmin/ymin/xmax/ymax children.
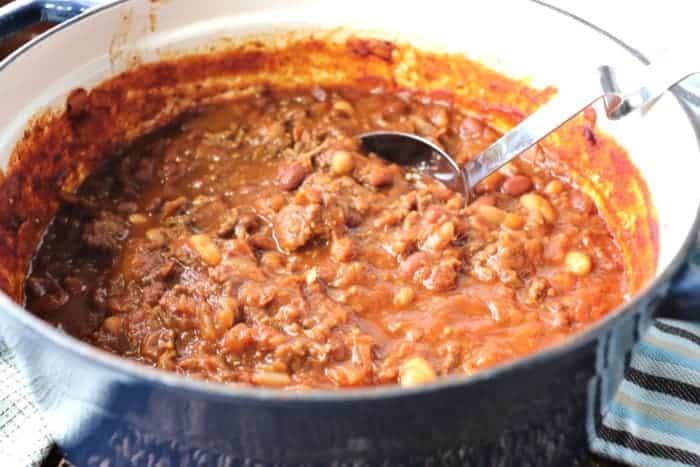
<box><xmin>359</xmin><ymin>56</ymin><xmax>700</xmax><ymax>204</ymax></box>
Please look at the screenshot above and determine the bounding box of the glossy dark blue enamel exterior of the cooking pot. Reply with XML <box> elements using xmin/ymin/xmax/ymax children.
<box><xmin>0</xmin><ymin>1</ymin><xmax>700</xmax><ymax>467</ymax></box>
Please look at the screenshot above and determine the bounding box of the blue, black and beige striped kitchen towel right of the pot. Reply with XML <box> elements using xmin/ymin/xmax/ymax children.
<box><xmin>588</xmin><ymin>320</ymin><xmax>700</xmax><ymax>467</ymax></box>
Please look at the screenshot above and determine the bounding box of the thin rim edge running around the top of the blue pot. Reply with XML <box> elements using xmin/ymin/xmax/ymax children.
<box><xmin>0</xmin><ymin>0</ymin><xmax>700</xmax><ymax>404</ymax></box>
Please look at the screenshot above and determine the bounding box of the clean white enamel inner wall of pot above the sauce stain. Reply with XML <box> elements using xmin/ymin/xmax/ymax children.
<box><xmin>0</xmin><ymin>0</ymin><xmax>700</xmax><ymax>286</ymax></box>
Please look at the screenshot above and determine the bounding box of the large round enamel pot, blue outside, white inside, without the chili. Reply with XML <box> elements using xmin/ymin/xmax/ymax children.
<box><xmin>0</xmin><ymin>0</ymin><xmax>700</xmax><ymax>466</ymax></box>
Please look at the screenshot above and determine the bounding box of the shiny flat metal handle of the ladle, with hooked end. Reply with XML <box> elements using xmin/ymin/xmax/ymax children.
<box><xmin>464</xmin><ymin>57</ymin><xmax>700</xmax><ymax>188</ymax></box>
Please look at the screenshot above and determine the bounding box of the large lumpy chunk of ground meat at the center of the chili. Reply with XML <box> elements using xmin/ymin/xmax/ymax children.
<box><xmin>274</xmin><ymin>204</ymin><xmax>321</xmax><ymax>251</ymax></box>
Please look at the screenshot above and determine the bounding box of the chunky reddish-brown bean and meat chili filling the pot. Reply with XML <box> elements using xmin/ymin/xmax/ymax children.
<box><xmin>26</xmin><ymin>88</ymin><xmax>626</xmax><ymax>389</ymax></box>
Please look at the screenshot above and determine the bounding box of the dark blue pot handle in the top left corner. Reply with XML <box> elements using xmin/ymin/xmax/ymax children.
<box><xmin>0</xmin><ymin>0</ymin><xmax>99</xmax><ymax>39</ymax></box>
